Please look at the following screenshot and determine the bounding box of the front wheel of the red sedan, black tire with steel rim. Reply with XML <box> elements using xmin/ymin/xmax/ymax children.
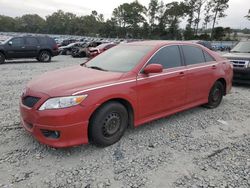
<box><xmin>89</xmin><ymin>102</ymin><xmax>128</xmax><ymax>147</ymax></box>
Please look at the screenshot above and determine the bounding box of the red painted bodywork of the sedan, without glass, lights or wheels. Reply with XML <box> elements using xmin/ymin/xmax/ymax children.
<box><xmin>20</xmin><ymin>41</ymin><xmax>232</xmax><ymax>147</ymax></box>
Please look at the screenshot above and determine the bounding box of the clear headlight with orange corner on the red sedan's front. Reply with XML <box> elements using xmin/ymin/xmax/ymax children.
<box><xmin>39</xmin><ymin>95</ymin><xmax>88</xmax><ymax>110</ymax></box>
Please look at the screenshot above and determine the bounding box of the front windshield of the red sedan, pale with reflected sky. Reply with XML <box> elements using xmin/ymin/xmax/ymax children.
<box><xmin>84</xmin><ymin>45</ymin><xmax>153</xmax><ymax>72</ymax></box>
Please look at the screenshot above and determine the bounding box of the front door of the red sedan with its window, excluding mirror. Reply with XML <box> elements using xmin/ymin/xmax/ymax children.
<box><xmin>137</xmin><ymin>45</ymin><xmax>186</xmax><ymax>118</ymax></box>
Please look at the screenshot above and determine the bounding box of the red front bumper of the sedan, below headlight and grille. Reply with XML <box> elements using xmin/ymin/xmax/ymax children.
<box><xmin>20</xmin><ymin>101</ymin><xmax>89</xmax><ymax>148</ymax></box>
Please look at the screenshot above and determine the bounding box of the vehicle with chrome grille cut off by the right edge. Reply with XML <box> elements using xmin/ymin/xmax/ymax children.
<box><xmin>223</xmin><ymin>40</ymin><xmax>250</xmax><ymax>84</ymax></box>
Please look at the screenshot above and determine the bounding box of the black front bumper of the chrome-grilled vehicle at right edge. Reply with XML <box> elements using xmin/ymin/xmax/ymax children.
<box><xmin>233</xmin><ymin>67</ymin><xmax>250</xmax><ymax>84</ymax></box>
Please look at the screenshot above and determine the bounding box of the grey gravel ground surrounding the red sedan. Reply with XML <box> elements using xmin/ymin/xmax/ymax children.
<box><xmin>0</xmin><ymin>56</ymin><xmax>250</xmax><ymax>188</ymax></box>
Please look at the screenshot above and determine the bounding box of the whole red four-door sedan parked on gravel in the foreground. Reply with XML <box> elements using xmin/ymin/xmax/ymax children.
<box><xmin>20</xmin><ymin>41</ymin><xmax>233</xmax><ymax>147</ymax></box>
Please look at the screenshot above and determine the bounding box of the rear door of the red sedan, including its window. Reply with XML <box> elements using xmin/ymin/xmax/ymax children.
<box><xmin>181</xmin><ymin>45</ymin><xmax>216</xmax><ymax>104</ymax></box>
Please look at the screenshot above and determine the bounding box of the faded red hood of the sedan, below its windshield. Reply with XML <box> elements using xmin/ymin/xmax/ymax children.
<box><xmin>26</xmin><ymin>65</ymin><xmax>124</xmax><ymax>97</ymax></box>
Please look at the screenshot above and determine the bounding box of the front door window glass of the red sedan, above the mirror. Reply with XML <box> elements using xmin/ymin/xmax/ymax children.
<box><xmin>149</xmin><ymin>46</ymin><xmax>182</xmax><ymax>69</ymax></box>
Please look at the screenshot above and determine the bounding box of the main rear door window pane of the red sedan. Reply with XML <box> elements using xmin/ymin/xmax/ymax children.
<box><xmin>182</xmin><ymin>46</ymin><xmax>206</xmax><ymax>65</ymax></box>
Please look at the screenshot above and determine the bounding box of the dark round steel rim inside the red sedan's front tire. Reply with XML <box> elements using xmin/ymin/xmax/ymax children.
<box><xmin>103</xmin><ymin>112</ymin><xmax>121</xmax><ymax>137</ymax></box>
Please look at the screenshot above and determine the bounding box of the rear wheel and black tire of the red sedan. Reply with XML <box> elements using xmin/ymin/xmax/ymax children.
<box><xmin>205</xmin><ymin>81</ymin><xmax>224</xmax><ymax>109</ymax></box>
